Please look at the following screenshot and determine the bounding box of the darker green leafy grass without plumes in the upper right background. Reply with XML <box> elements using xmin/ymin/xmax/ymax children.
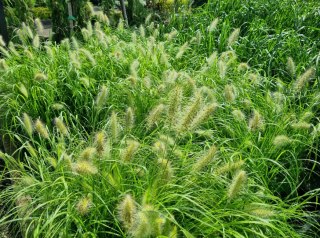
<box><xmin>164</xmin><ymin>0</ymin><xmax>320</xmax><ymax>81</ymax></box>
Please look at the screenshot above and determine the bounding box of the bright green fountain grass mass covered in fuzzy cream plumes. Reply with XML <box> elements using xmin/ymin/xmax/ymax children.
<box><xmin>0</xmin><ymin>15</ymin><xmax>320</xmax><ymax>237</ymax></box>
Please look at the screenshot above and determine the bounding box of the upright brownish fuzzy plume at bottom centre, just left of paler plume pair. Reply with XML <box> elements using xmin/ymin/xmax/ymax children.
<box><xmin>118</xmin><ymin>194</ymin><xmax>137</xmax><ymax>230</ymax></box>
